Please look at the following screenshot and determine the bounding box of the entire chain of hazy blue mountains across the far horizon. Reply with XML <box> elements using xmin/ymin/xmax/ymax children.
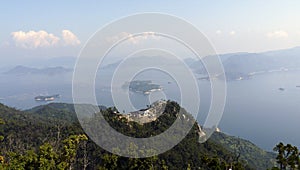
<box><xmin>1</xmin><ymin>47</ymin><xmax>300</xmax><ymax>80</ymax></box>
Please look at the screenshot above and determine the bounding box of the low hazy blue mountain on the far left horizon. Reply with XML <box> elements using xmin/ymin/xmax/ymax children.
<box><xmin>3</xmin><ymin>65</ymin><xmax>72</xmax><ymax>75</ymax></box>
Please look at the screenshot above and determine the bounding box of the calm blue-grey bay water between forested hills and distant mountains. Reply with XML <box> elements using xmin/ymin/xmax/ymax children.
<box><xmin>0</xmin><ymin>71</ymin><xmax>300</xmax><ymax>150</ymax></box>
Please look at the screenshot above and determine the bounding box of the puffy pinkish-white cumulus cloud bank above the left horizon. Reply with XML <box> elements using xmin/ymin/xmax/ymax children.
<box><xmin>11</xmin><ymin>30</ymin><xmax>80</xmax><ymax>49</ymax></box>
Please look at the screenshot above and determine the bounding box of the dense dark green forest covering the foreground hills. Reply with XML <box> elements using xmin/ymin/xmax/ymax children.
<box><xmin>0</xmin><ymin>101</ymin><xmax>294</xmax><ymax>169</ymax></box>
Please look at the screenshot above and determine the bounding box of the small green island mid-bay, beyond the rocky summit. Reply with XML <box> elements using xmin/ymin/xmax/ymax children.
<box><xmin>123</xmin><ymin>80</ymin><xmax>162</xmax><ymax>95</ymax></box>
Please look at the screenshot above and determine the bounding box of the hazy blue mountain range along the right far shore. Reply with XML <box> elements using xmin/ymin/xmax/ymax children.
<box><xmin>185</xmin><ymin>47</ymin><xmax>300</xmax><ymax>80</ymax></box>
